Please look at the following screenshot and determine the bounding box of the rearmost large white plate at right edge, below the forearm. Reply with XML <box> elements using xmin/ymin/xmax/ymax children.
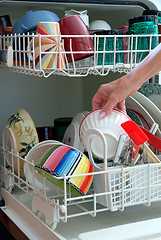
<box><xmin>133</xmin><ymin>92</ymin><xmax>161</xmax><ymax>133</ymax></box>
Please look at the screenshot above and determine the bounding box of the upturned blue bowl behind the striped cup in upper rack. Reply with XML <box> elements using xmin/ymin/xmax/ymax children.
<box><xmin>12</xmin><ymin>10</ymin><xmax>60</xmax><ymax>34</ymax></box>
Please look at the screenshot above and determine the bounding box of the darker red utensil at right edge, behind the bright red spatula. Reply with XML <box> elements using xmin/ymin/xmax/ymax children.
<box><xmin>140</xmin><ymin>126</ymin><xmax>161</xmax><ymax>152</ymax></box>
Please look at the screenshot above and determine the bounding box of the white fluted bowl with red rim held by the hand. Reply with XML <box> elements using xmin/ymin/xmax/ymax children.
<box><xmin>79</xmin><ymin>109</ymin><xmax>131</xmax><ymax>159</ymax></box>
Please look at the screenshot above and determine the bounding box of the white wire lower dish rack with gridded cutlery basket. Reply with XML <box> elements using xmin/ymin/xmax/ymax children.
<box><xmin>1</xmin><ymin>144</ymin><xmax>161</xmax><ymax>229</ymax></box>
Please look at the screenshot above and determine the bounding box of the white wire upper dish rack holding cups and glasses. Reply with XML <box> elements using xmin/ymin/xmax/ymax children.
<box><xmin>0</xmin><ymin>34</ymin><xmax>160</xmax><ymax>77</ymax></box>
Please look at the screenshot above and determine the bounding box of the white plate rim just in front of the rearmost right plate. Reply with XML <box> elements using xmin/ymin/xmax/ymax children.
<box><xmin>126</xmin><ymin>96</ymin><xmax>161</xmax><ymax>138</ymax></box>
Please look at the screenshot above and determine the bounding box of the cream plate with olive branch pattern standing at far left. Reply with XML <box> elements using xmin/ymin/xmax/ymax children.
<box><xmin>3</xmin><ymin>108</ymin><xmax>39</xmax><ymax>177</ymax></box>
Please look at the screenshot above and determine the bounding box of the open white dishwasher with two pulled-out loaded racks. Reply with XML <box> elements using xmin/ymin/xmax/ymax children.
<box><xmin>0</xmin><ymin>0</ymin><xmax>161</xmax><ymax>240</ymax></box>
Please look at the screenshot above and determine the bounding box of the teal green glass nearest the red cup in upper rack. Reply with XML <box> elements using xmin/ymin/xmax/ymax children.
<box><xmin>97</xmin><ymin>30</ymin><xmax>124</xmax><ymax>65</ymax></box>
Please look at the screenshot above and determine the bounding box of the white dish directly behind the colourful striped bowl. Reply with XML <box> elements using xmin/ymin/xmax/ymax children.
<box><xmin>24</xmin><ymin>140</ymin><xmax>62</xmax><ymax>191</ymax></box>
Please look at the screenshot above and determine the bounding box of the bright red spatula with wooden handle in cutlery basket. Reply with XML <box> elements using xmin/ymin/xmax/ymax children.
<box><xmin>121</xmin><ymin>121</ymin><xmax>160</xmax><ymax>163</ymax></box>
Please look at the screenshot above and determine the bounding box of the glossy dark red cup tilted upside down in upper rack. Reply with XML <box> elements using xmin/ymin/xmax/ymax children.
<box><xmin>59</xmin><ymin>15</ymin><xmax>94</xmax><ymax>62</ymax></box>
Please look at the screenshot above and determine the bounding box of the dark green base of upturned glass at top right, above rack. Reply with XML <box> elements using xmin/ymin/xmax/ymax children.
<box><xmin>129</xmin><ymin>15</ymin><xmax>158</xmax><ymax>27</ymax></box>
